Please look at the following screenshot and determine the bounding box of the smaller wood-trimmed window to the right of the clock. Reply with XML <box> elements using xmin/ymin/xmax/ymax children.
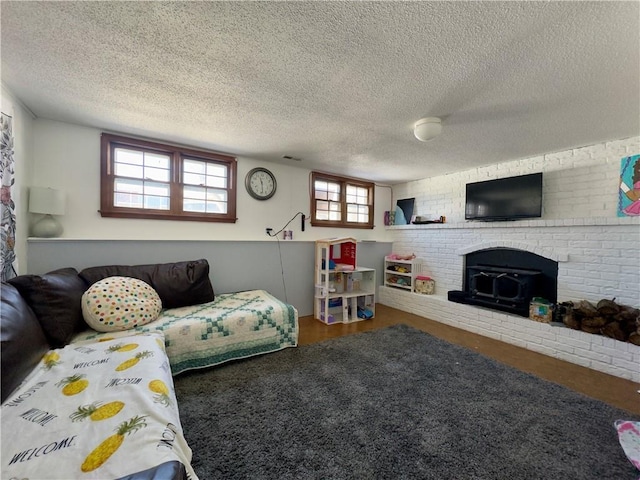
<box><xmin>311</xmin><ymin>172</ymin><xmax>375</xmax><ymax>228</ymax></box>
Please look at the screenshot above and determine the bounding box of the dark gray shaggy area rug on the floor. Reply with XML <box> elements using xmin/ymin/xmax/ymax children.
<box><xmin>175</xmin><ymin>325</ymin><xmax>638</xmax><ymax>480</ymax></box>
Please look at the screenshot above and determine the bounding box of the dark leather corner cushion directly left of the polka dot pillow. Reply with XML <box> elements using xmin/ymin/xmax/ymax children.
<box><xmin>9</xmin><ymin>268</ymin><xmax>87</xmax><ymax>348</ymax></box>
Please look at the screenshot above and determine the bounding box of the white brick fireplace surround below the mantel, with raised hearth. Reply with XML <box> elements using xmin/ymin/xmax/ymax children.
<box><xmin>379</xmin><ymin>225</ymin><xmax>640</xmax><ymax>382</ymax></box>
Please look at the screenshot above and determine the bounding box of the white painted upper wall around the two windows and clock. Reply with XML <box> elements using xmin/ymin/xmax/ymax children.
<box><xmin>33</xmin><ymin>119</ymin><xmax>391</xmax><ymax>241</ymax></box>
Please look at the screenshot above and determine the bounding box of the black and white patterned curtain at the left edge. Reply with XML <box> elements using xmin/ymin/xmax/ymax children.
<box><xmin>0</xmin><ymin>113</ymin><xmax>16</xmax><ymax>281</ymax></box>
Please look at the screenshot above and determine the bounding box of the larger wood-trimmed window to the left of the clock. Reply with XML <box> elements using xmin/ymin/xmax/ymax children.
<box><xmin>100</xmin><ymin>133</ymin><xmax>237</xmax><ymax>223</ymax></box>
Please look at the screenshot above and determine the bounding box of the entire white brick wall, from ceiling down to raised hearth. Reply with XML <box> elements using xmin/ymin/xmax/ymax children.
<box><xmin>379</xmin><ymin>137</ymin><xmax>640</xmax><ymax>382</ymax></box>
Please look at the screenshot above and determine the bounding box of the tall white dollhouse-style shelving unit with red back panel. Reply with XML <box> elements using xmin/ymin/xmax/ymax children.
<box><xmin>313</xmin><ymin>238</ymin><xmax>376</xmax><ymax>325</ymax></box>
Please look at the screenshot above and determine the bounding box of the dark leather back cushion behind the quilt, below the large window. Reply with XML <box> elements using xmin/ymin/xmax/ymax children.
<box><xmin>80</xmin><ymin>259</ymin><xmax>214</xmax><ymax>308</ymax></box>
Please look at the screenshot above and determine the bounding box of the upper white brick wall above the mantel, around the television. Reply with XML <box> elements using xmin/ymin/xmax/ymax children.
<box><xmin>393</xmin><ymin>137</ymin><xmax>640</xmax><ymax>222</ymax></box>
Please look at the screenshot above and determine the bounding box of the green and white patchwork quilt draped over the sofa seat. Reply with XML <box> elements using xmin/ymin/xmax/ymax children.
<box><xmin>73</xmin><ymin>290</ymin><xmax>298</xmax><ymax>375</ymax></box>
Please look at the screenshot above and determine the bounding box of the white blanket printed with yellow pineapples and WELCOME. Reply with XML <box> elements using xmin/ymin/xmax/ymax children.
<box><xmin>0</xmin><ymin>332</ymin><xmax>197</xmax><ymax>480</ymax></box>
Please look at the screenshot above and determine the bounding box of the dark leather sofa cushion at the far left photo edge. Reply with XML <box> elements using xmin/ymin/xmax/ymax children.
<box><xmin>0</xmin><ymin>282</ymin><xmax>49</xmax><ymax>402</ymax></box>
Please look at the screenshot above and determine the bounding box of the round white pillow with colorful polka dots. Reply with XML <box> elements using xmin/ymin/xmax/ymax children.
<box><xmin>82</xmin><ymin>277</ymin><xmax>162</xmax><ymax>332</ymax></box>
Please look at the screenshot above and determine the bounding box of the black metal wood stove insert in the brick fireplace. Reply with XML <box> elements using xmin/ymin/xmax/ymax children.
<box><xmin>448</xmin><ymin>248</ymin><xmax>558</xmax><ymax>317</ymax></box>
